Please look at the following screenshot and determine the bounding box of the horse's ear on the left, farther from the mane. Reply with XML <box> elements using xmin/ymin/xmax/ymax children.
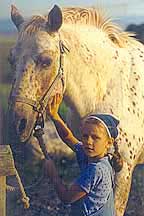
<box><xmin>11</xmin><ymin>5</ymin><xmax>24</xmax><ymax>30</ymax></box>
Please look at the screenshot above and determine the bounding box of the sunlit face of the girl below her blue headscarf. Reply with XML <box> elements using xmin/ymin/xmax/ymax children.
<box><xmin>81</xmin><ymin>122</ymin><xmax>113</xmax><ymax>158</ymax></box>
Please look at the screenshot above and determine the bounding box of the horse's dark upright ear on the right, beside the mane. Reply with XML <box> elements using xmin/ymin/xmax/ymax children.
<box><xmin>47</xmin><ymin>5</ymin><xmax>62</xmax><ymax>32</ymax></box>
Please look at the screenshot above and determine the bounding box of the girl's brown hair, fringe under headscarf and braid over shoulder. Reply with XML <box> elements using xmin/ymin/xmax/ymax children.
<box><xmin>82</xmin><ymin>118</ymin><xmax>123</xmax><ymax>172</ymax></box>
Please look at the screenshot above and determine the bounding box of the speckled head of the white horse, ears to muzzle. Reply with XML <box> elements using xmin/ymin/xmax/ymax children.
<box><xmin>9</xmin><ymin>6</ymin><xmax>64</xmax><ymax>142</ymax></box>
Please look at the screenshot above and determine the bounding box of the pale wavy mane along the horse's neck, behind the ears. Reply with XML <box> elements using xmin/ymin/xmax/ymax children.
<box><xmin>63</xmin><ymin>7</ymin><xmax>134</xmax><ymax>47</ymax></box>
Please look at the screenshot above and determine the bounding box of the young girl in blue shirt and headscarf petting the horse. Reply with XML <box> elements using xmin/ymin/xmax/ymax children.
<box><xmin>34</xmin><ymin>94</ymin><xmax>122</xmax><ymax>216</ymax></box>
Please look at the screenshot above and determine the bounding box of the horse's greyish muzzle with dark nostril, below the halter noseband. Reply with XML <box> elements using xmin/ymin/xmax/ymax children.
<box><xmin>9</xmin><ymin>102</ymin><xmax>37</xmax><ymax>143</ymax></box>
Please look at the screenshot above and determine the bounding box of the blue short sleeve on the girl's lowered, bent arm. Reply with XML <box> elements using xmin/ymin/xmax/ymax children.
<box><xmin>75</xmin><ymin>164</ymin><xmax>102</xmax><ymax>193</ymax></box>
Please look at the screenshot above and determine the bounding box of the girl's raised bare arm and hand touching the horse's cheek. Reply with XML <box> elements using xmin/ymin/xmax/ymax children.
<box><xmin>47</xmin><ymin>94</ymin><xmax>79</xmax><ymax>151</ymax></box>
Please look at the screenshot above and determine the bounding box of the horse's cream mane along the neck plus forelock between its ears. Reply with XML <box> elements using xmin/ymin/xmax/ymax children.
<box><xmin>21</xmin><ymin>7</ymin><xmax>134</xmax><ymax>47</ymax></box>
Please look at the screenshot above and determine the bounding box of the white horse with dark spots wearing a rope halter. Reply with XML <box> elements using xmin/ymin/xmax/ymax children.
<box><xmin>10</xmin><ymin>6</ymin><xmax>144</xmax><ymax>216</ymax></box>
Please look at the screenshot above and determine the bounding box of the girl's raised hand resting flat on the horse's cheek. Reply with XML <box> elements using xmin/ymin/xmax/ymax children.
<box><xmin>47</xmin><ymin>93</ymin><xmax>62</xmax><ymax>119</ymax></box>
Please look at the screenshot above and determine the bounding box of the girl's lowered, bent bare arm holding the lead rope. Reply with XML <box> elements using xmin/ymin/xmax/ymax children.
<box><xmin>45</xmin><ymin>159</ymin><xmax>86</xmax><ymax>203</ymax></box>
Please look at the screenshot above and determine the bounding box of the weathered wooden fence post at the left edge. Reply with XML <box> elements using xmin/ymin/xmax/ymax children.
<box><xmin>0</xmin><ymin>145</ymin><xmax>16</xmax><ymax>216</ymax></box>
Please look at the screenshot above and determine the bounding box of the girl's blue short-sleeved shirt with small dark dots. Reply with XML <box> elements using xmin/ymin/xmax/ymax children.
<box><xmin>71</xmin><ymin>143</ymin><xmax>114</xmax><ymax>216</ymax></box>
